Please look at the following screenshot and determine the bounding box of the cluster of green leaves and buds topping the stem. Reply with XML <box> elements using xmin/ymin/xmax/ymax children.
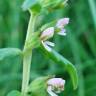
<box><xmin>22</xmin><ymin>0</ymin><xmax>64</xmax><ymax>13</ymax></box>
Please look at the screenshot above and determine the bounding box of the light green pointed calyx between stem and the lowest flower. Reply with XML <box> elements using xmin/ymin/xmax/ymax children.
<box><xmin>28</xmin><ymin>76</ymin><xmax>53</xmax><ymax>96</ymax></box>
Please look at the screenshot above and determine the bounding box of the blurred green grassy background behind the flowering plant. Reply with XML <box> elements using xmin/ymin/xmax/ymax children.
<box><xmin>0</xmin><ymin>0</ymin><xmax>96</xmax><ymax>96</ymax></box>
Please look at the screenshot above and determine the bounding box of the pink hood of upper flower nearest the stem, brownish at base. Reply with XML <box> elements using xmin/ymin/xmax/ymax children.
<box><xmin>40</xmin><ymin>27</ymin><xmax>54</xmax><ymax>41</ymax></box>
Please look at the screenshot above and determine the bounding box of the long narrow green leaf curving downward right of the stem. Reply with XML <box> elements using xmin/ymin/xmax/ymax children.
<box><xmin>40</xmin><ymin>45</ymin><xmax>78</xmax><ymax>89</ymax></box>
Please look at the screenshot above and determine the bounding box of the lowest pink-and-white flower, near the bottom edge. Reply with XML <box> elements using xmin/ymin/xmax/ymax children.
<box><xmin>47</xmin><ymin>78</ymin><xmax>65</xmax><ymax>96</ymax></box>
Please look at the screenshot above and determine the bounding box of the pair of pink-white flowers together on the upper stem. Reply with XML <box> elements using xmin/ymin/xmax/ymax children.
<box><xmin>40</xmin><ymin>18</ymin><xmax>69</xmax><ymax>51</ymax></box>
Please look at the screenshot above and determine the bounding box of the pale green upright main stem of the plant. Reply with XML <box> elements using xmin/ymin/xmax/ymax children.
<box><xmin>22</xmin><ymin>14</ymin><xmax>36</xmax><ymax>96</ymax></box>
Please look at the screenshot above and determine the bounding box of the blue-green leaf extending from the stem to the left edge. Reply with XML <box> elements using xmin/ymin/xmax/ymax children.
<box><xmin>0</xmin><ymin>48</ymin><xmax>22</xmax><ymax>61</ymax></box>
